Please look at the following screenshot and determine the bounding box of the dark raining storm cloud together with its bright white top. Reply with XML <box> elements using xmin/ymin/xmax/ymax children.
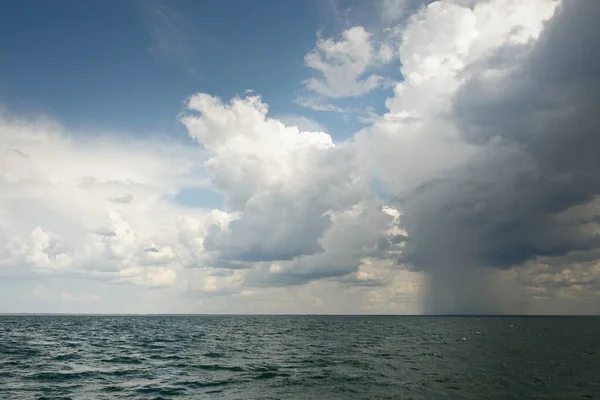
<box><xmin>370</xmin><ymin>1</ymin><xmax>600</xmax><ymax>312</ymax></box>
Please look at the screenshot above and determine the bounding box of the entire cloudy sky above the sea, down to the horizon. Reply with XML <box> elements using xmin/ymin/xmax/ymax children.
<box><xmin>0</xmin><ymin>0</ymin><xmax>600</xmax><ymax>314</ymax></box>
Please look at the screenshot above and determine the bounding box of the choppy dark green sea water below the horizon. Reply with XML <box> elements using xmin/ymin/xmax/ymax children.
<box><xmin>0</xmin><ymin>316</ymin><xmax>600</xmax><ymax>399</ymax></box>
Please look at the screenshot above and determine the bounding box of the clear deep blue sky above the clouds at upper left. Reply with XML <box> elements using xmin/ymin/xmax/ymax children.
<box><xmin>0</xmin><ymin>0</ymin><xmax>389</xmax><ymax>139</ymax></box>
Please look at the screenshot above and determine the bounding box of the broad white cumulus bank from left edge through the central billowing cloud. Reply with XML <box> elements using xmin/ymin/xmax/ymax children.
<box><xmin>0</xmin><ymin>94</ymin><xmax>408</xmax><ymax>310</ymax></box>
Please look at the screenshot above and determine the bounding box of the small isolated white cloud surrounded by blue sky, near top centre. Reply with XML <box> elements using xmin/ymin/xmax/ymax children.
<box><xmin>304</xmin><ymin>26</ymin><xmax>393</xmax><ymax>98</ymax></box>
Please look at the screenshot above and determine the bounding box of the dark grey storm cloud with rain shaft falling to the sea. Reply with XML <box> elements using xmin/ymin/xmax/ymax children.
<box><xmin>398</xmin><ymin>1</ymin><xmax>600</xmax><ymax>312</ymax></box>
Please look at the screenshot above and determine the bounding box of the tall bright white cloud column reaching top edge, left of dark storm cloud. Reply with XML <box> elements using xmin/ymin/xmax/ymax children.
<box><xmin>356</xmin><ymin>0</ymin><xmax>556</xmax><ymax>194</ymax></box>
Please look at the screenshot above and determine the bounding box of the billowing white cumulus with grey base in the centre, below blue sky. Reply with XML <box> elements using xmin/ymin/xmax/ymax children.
<box><xmin>182</xmin><ymin>94</ymin><xmax>368</xmax><ymax>262</ymax></box>
